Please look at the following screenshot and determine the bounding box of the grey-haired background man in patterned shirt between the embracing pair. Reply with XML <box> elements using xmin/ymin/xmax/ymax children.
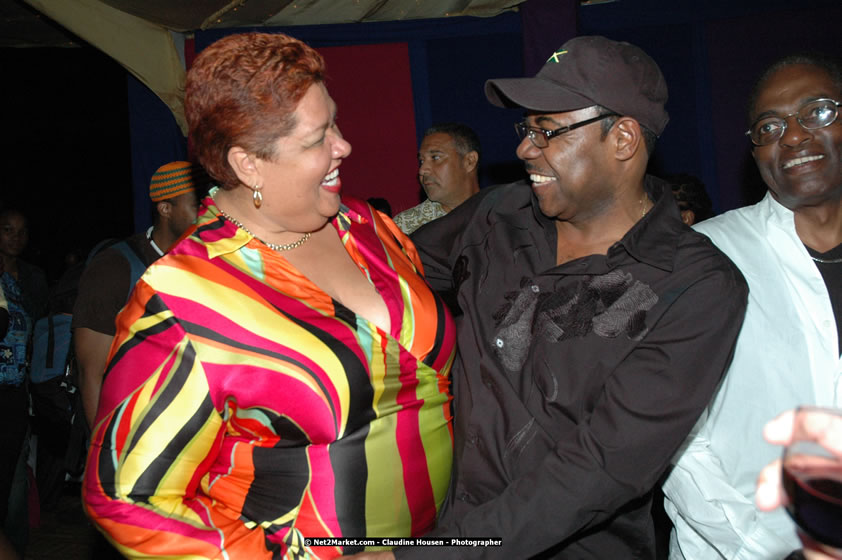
<box><xmin>395</xmin><ymin>123</ymin><xmax>482</xmax><ymax>235</ymax></box>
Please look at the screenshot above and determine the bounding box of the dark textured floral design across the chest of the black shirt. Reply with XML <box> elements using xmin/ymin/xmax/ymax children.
<box><xmin>492</xmin><ymin>270</ymin><xmax>658</xmax><ymax>371</ymax></box>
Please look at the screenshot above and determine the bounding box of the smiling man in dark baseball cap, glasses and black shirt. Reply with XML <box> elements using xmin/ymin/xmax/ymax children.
<box><xmin>352</xmin><ymin>37</ymin><xmax>747</xmax><ymax>560</ymax></box>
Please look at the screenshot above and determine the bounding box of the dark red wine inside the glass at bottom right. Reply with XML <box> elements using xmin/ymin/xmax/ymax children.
<box><xmin>783</xmin><ymin>460</ymin><xmax>842</xmax><ymax>555</ymax></box>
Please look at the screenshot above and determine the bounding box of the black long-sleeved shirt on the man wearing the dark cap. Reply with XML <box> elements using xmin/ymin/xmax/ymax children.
<box><xmin>404</xmin><ymin>177</ymin><xmax>748</xmax><ymax>560</ymax></box>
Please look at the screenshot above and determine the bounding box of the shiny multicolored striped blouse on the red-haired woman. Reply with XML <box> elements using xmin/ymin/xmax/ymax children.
<box><xmin>83</xmin><ymin>190</ymin><xmax>455</xmax><ymax>559</ymax></box>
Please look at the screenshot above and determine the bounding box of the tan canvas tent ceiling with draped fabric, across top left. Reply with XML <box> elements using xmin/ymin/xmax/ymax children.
<box><xmin>6</xmin><ymin>0</ymin><xmax>525</xmax><ymax>134</ymax></box>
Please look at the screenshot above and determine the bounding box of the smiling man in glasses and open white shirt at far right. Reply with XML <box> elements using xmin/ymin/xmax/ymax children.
<box><xmin>664</xmin><ymin>56</ymin><xmax>842</xmax><ymax>560</ymax></box>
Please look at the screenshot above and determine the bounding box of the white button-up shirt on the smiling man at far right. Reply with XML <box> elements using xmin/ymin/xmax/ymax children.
<box><xmin>664</xmin><ymin>193</ymin><xmax>842</xmax><ymax>560</ymax></box>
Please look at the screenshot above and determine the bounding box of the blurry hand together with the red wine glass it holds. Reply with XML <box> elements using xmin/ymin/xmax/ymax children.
<box><xmin>756</xmin><ymin>407</ymin><xmax>842</xmax><ymax>559</ymax></box>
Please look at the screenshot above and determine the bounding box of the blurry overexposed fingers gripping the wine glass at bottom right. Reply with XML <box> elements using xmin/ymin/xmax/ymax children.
<box><xmin>755</xmin><ymin>409</ymin><xmax>842</xmax><ymax>560</ymax></box>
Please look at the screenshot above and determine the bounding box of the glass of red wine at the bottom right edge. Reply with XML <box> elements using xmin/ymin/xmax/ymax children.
<box><xmin>783</xmin><ymin>407</ymin><xmax>842</xmax><ymax>558</ymax></box>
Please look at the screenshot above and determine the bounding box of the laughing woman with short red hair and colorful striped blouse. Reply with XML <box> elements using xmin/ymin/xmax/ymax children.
<box><xmin>84</xmin><ymin>33</ymin><xmax>455</xmax><ymax>559</ymax></box>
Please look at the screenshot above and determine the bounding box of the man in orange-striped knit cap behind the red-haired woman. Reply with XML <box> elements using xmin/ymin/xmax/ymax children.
<box><xmin>72</xmin><ymin>161</ymin><xmax>202</xmax><ymax>426</ymax></box>
